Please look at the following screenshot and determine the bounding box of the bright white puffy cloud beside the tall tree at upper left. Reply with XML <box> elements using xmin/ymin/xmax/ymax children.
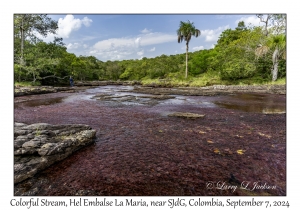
<box><xmin>57</xmin><ymin>15</ymin><xmax>93</xmax><ymax>38</ymax></box>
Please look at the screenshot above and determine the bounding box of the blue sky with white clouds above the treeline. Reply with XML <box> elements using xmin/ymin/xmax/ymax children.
<box><xmin>45</xmin><ymin>14</ymin><xmax>260</xmax><ymax>61</ymax></box>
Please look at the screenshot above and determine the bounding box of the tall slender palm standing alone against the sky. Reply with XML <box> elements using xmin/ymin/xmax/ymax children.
<box><xmin>177</xmin><ymin>20</ymin><xmax>201</xmax><ymax>78</ymax></box>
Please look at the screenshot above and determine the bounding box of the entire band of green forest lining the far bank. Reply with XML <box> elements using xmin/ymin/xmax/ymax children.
<box><xmin>14</xmin><ymin>14</ymin><xmax>286</xmax><ymax>86</ymax></box>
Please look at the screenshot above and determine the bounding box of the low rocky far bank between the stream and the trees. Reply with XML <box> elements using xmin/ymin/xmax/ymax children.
<box><xmin>14</xmin><ymin>81</ymin><xmax>286</xmax><ymax>96</ymax></box>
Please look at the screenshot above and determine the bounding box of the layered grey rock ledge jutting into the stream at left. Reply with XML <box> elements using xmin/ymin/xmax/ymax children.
<box><xmin>14</xmin><ymin>122</ymin><xmax>96</xmax><ymax>183</ymax></box>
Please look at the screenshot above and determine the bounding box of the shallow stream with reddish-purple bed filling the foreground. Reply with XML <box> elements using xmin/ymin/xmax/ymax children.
<box><xmin>14</xmin><ymin>86</ymin><xmax>286</xmax><ymax>196</ymax></box>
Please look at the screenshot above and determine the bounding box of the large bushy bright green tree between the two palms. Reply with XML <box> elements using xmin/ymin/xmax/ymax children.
<box><xmin>212</xmin><ymin>24</ymin><xmax>263</xmax><ymax>81</ymax></box>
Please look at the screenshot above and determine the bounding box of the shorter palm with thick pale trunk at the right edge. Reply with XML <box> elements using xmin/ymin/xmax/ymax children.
<box><xmin>255</xmin><ymin>34</ymin><xmax>286</xmax><ymax>81</ymax></box>
